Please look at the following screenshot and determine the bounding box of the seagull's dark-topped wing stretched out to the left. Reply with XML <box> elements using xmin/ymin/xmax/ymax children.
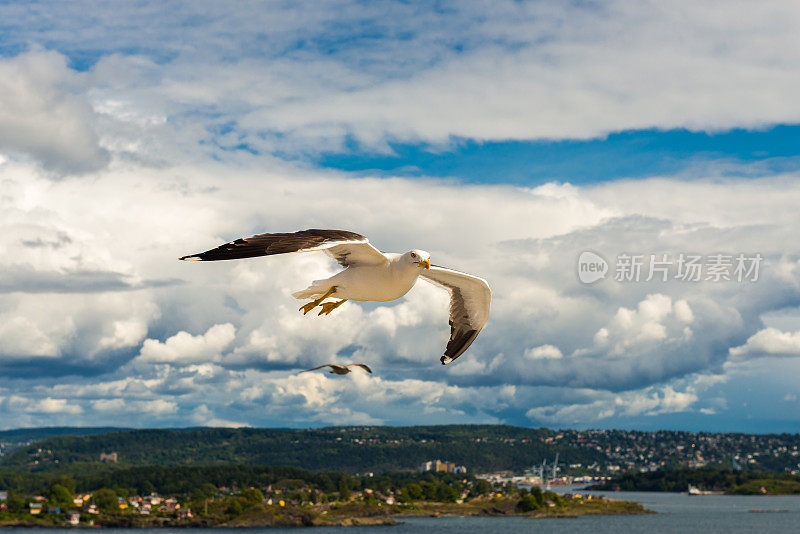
<box><xmin>181</xmin><ymin>229</ymin><xmax>389</xmax><ymax>267</ymax></box>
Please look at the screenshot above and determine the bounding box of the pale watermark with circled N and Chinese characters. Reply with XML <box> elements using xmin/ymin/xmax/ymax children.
<box><xmin>578</xmin><ymin>250</ymin><xmax>764</xmax><ymax>284</ymax></box>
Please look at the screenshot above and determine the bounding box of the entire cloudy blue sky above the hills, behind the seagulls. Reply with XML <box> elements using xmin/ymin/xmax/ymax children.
<box><xmin>0</xmin><ymin>0</ymin><xmax>800</xmax><ymax>432</ymax></box>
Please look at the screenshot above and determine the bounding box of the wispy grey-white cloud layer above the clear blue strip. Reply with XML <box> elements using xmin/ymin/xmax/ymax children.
<box><xmin>0</xmin><ymin>0</ymin><xmax>800</xmax><ymax>166</ymax></box>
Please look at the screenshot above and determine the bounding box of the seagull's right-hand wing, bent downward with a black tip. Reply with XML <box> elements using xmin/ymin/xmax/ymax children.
<box><xmin>420</xmin><ymin>265</ymin><xmax>492</xmax><ymax>365</ymax></box>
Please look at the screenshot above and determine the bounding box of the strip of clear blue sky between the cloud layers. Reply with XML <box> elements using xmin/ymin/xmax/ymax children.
<box><xmin>312</xmin><ymin>124</ymin><xmax>800</xmax><ymax>186</ymax></box>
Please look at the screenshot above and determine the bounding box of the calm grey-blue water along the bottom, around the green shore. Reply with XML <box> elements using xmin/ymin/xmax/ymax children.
<box><xmin>5</xmin><ymin>492</ymin><xmax>800</xmax><ymax>534</ymax></box>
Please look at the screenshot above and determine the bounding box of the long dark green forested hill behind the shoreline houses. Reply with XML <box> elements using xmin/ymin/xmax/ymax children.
<box><xmin>0</xmin><ymin>425</ymin><xmax>605</xmax><ymax>473</ymax></box>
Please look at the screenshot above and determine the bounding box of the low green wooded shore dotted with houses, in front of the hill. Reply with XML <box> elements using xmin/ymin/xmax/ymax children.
<box><xmin>0</xmin><ymin>465</ymin><xmax>651</xmax><ymax>528</ymax></box>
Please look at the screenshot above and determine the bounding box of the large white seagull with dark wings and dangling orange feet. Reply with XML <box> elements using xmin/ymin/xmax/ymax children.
<box><xmin>181</xmin><ymin>230</ymin><xmax>492</xmax><ymax>365</ymax></box>
